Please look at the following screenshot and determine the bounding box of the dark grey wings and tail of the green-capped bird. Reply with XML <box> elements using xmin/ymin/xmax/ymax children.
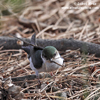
<box><xmin>22</xmin><ymin>34</ymin><xmax>43</xmax><ymax>69</ymax></box>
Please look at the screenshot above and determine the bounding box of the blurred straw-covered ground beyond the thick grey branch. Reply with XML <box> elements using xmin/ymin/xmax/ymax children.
<box><xmin>0</xmin><ymin>0</ymin><xmax>100</xmax><ymax>43</ymax></box>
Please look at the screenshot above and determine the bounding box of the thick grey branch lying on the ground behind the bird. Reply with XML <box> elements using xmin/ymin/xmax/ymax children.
<box><xmin>0</xmin><ymin>37</ymin><xmax>100</xmax><ymax>57</ymax></box>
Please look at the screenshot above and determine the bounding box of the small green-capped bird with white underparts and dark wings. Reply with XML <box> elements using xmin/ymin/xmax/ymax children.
<box><xmin>22</xmin><ymin>34</ymin><xmax>64</xmax><ymax>83</ymax></box>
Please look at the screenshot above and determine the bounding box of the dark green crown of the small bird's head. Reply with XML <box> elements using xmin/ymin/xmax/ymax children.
<box><xmin>42</xmin><ymin>46</ymin><xmax>58</xmax><ymax>61</ymax></box>
